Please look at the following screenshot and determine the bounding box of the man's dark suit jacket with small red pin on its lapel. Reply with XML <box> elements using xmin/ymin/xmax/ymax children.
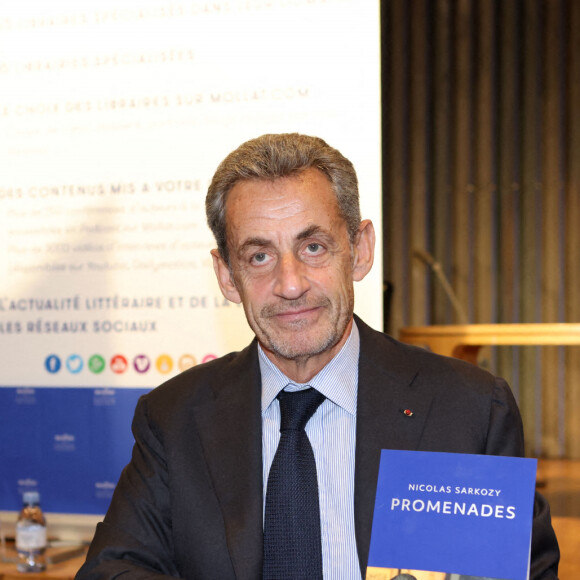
<box><xmin>77</xmin><ymin>318</ymin><xmax>559</xmax><ymax>580</ymax></box>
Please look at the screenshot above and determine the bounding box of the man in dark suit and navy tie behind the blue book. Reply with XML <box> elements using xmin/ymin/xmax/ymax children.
<box><xmin>77</xmin><ymin>134</ymin><xmax>559</xmax><ymax>580</ymax></box>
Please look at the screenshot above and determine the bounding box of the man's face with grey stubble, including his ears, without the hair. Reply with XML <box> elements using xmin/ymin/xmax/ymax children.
<box><xmin>213</xmin><ymin>169</ymin><xmax>374</xmax><ymax>376</ymax></box>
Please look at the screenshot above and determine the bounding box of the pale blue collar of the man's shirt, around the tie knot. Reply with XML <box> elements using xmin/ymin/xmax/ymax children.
<box><xmin>258</xmin><ymin>321</ymin><xmax>360</xmax><ymax>416</ymax></box>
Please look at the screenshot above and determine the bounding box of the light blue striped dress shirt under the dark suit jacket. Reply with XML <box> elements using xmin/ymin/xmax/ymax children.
<box><xmin>258</xmin><ymin>322</ymin><xmax>361</xmax><ymax>580</ymax></box>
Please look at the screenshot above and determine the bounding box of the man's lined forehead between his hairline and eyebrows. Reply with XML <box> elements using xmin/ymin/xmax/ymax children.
<box><xmin>226</xmin><ymin>168</ymin><xmax>344</xmax><ymax>242</ymax></box>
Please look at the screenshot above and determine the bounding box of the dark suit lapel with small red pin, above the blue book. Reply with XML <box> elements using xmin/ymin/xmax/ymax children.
<box><xmin>354</xmin><ymin>318</ymin><xmax>431</xmax><ymax>578</ymax></box>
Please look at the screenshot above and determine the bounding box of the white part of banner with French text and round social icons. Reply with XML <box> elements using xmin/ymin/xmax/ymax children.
<box><xmin>0</xmin><ymin>0</ymin><xmax>382</xmax><ymax>520</ymax></box>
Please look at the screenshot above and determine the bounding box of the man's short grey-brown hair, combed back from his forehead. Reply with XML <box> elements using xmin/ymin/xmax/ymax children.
<box><xmin>205</xmin><ymin>133</ymin><xmax>361</xmax><ymax>264</ymax></box>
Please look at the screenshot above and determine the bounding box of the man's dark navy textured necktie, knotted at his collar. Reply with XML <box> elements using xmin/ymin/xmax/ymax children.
<box><xmin>263</xmin><ymin>389</ymin><xmax>325</xmax><ymax>580</ymax></box>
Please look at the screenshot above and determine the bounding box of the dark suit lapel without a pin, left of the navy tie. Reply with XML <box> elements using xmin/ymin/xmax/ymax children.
<box><xmin>194</xmin><ymin>341</ymin><xmax>262</xmax><ymax>579</ymax></box>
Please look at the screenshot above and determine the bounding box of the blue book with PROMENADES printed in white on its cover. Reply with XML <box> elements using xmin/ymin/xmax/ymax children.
<box><xmin>367</xmin><ymin>450</ymin><xmax>537</xmax><ymax>580</ymax></box>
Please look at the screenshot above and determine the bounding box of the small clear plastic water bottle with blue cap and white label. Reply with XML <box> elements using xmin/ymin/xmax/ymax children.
<box><xmin>16</xmin><ymin>491</ymin><xmax>46</xmax><ymax>572</ymax></box>
